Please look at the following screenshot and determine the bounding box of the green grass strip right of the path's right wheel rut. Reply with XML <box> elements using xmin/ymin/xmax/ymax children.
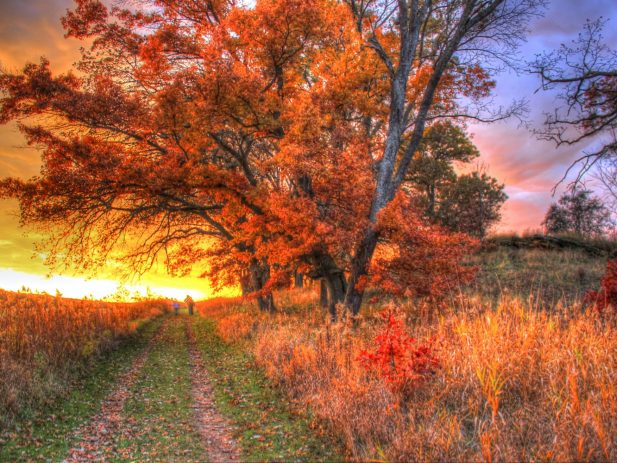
<box><xmin>193</xmin><ymin>317</ymin><xmax>344</xmax><ymax>461</ymax></box>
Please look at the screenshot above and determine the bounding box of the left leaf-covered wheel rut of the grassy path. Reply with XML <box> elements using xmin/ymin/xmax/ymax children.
<box><xmin>63</xmin><ymin>319</ymin><xmax>169</xmax><ymax>463</ymax></box>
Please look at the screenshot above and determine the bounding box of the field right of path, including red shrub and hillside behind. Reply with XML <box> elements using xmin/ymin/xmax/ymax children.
<box><xmin>202</xmin><ymin>248</ymin><xmax>617</xmax><ymax>461</ymax></box>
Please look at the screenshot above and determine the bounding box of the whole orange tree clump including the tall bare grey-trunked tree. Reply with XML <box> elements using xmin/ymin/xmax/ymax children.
<box><xmin>0</xmin><ymin>0</ymin><xmax>541</xmax><ymax>313</ymax></box>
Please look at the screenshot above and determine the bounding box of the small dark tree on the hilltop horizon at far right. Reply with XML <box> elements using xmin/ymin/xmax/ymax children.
<box><xmin>543</xmin><ymin>188</ymin><xmax>610</xmax><ymax>237</ymax></box>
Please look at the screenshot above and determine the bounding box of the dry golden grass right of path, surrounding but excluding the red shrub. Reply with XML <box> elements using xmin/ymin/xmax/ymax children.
<box><xmin>206</xmin><ymin>294</ymin><xmax>617</xmax><ymax>461</ymax></box>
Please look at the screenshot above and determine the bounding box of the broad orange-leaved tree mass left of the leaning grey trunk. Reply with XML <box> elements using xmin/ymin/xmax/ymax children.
<box><xmin>0</xmin><ymin>0</ymin><xmax>385</xmax><ymax>316</ymax></box>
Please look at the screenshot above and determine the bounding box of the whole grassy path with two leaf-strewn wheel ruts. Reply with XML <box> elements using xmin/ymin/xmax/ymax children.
<box><xmin>0</xmin><ymin>315</ymin><xmax>342</xmax><ymax>463</ymax></box>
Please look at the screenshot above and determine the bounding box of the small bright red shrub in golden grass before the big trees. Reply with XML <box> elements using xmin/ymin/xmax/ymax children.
<box><xmin>359</xmin><ymin>309</ymin><xmax>440</xmax><ymax>396</ymax></box>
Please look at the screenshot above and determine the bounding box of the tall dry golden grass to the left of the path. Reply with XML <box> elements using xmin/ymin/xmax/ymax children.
<box><xmin>0</xmin><ymin>290</ymin><xmax>166</xmax><ymax>421</ymax></box>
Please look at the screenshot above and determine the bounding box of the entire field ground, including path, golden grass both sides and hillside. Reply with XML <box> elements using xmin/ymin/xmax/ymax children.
<box><xmin>0</xmin><ymin>246</ymin><xmax>617</xmax><ymax>461</ymax></box>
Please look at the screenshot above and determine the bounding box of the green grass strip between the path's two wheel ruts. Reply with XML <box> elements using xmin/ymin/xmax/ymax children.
<box><xmin>104</xmin><ymin>315</ymin><xmax>206</xmax><ymax>463</ymax></box>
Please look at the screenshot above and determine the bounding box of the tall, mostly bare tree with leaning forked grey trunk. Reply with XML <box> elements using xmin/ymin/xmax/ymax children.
<box><xmin>336</xmin><ymin>0</ymin><xmax>542</xmax><ymax>313</ymax></box>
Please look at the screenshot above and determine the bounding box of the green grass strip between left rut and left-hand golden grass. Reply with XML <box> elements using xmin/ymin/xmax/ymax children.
<box><xmin>0</xmin><ymin>318</ymin><xmax>162</xmax><ymax>462</ymax></box>
